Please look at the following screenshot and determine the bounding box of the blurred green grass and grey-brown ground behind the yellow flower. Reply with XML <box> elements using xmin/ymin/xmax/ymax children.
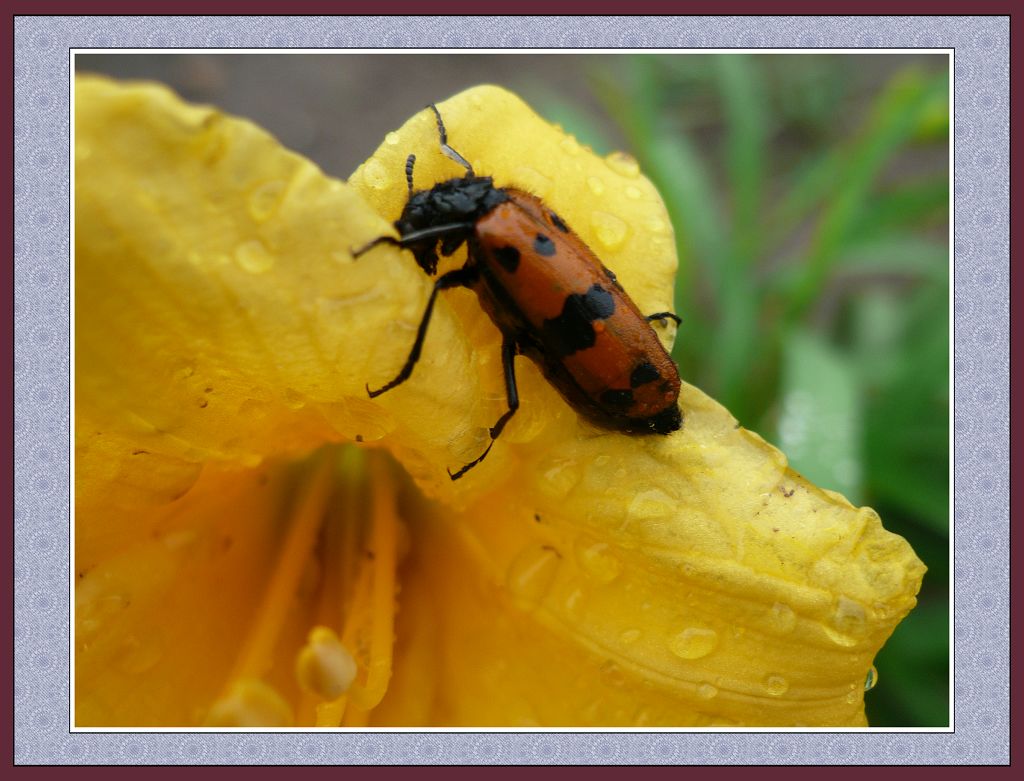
<box><xmin>76</xmin><ymin>52</ymin><xmax>950</xmax><ymax>727</ymax></box>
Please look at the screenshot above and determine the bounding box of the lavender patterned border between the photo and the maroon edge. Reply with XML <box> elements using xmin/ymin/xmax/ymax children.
<box><xmin>14</xmin><ymin>16</ymin><xmax>1010</xmax><ymax>765</ymax></box>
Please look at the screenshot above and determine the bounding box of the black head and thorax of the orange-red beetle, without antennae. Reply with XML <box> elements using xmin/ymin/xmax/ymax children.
<box><xmin>394</xmin><ymin>175</ymin><xmax>508</xmax><ymax>275</ymax></box>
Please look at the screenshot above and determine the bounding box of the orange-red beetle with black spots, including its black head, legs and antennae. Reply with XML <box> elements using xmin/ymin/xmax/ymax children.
<box><xmin>353</xmin><ymin>103</ymin><xmax>683</xmax><ymax>480</ymax></box>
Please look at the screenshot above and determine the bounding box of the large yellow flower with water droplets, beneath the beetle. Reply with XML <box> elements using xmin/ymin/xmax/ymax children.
<box><xmin>75</xmin><ymin>78</ymin><xmax>924</xmax><ymax>727</ymax></box>
